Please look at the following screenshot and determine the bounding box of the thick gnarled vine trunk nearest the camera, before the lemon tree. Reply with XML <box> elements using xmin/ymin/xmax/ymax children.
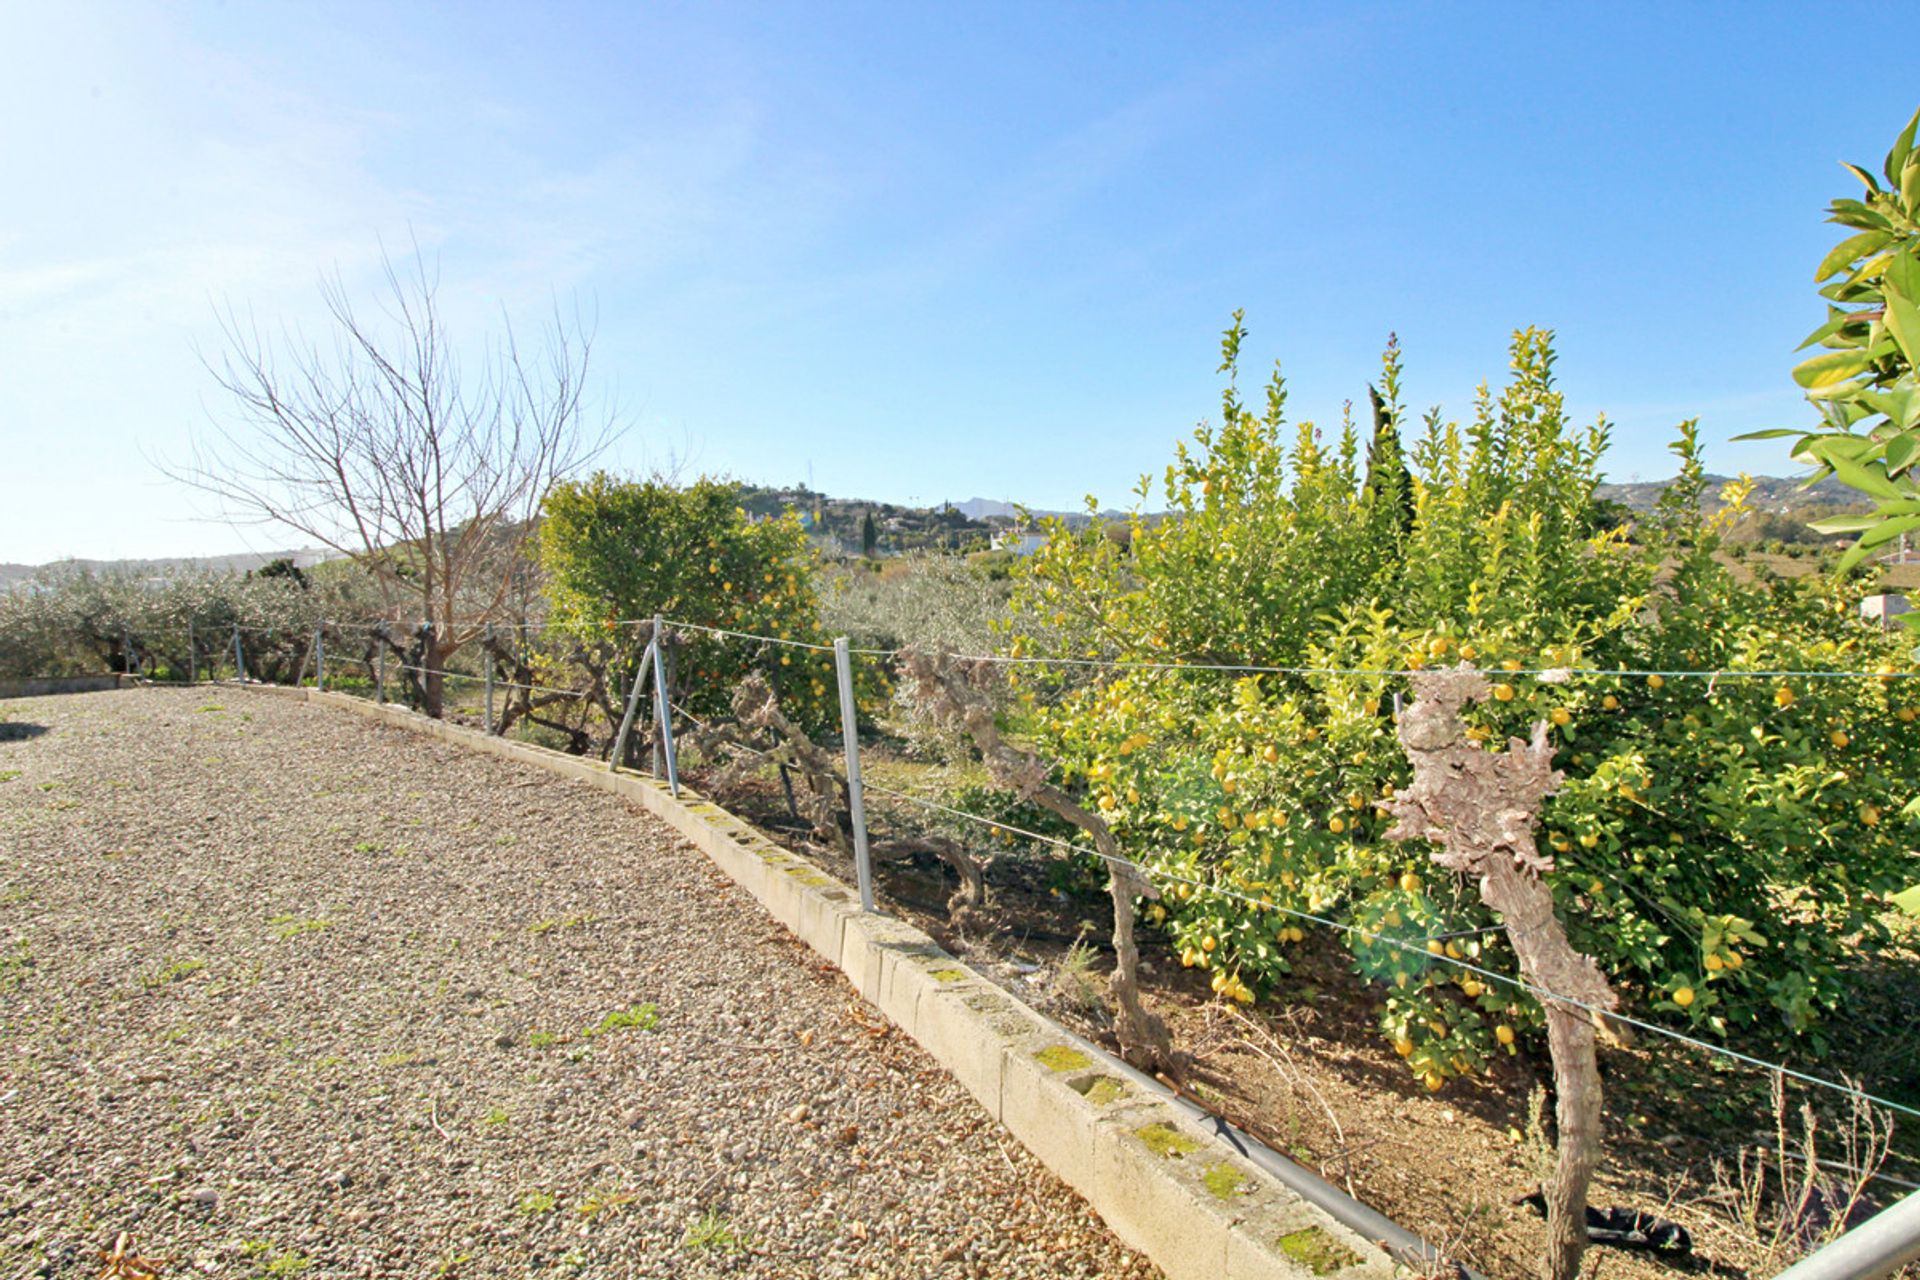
<box><xmin>1380</xmin><ymin>664</ymin><xmax>1624</xmax><ymax>1280</ymax></box>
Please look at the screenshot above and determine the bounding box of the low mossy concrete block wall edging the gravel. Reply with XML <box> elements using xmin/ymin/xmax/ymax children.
<box><xmin>307</xmin><ymin>691</ymin><xmax>1396</xmax><ymax>1280</ymax></box>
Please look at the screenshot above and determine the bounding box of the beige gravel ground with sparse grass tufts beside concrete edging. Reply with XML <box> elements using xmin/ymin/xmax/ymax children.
<box><xmin>0</xmin><ymin>689</ymin><xmax>1156</xmax><ymax>1278</ymax></box>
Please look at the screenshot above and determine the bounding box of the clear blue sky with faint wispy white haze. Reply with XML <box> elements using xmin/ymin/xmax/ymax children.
<box><xmin>0</xmin><ymin>0</ymin><xmax>1920</xmax><ymax>562</ymax></box>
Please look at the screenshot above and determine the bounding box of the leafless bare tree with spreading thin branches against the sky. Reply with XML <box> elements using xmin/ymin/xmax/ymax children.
<box><xmin>163</xmin><ymin>248</ymin><xmax>614</xmax><ymax>716</ymax></box>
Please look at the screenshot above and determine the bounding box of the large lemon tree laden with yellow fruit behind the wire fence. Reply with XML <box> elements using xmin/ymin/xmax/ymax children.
<box><xmin>1008</xmin><ymin>320</ymin><xmax>1920</xmax><ymax>1086</ymax></box>
